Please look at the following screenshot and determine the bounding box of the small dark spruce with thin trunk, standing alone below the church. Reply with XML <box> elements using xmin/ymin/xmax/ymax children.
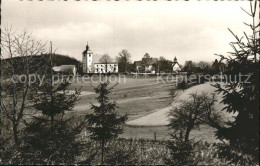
<box><xmin>86</xmin><ymin>81</ymin><xmax>127</xmax><ymax>164</ymax></box>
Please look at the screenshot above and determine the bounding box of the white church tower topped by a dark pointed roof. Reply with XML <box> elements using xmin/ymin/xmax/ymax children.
<box><xmin>82</xmin><ymin>44</ymin><xmax>93</xmax><ymax>73</ymax></box>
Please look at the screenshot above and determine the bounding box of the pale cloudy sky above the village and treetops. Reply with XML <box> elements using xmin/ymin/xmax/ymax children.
<box><xmin>2</xmin><ymin>0</ymin><xmax>254</xmax><ymax>64</ymax></box>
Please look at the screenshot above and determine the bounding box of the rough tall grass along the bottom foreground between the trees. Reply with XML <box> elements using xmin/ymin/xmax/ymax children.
<box><xmin>78</xmin><ymin>138</ymin><xmax>227</xmax><ymax>165</ymax></box>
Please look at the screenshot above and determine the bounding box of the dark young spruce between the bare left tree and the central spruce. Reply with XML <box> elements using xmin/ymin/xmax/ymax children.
<box><xmin>30</xmin><ymin>58</ymin><xmax>80</xmax><ymax>128</ymax></box>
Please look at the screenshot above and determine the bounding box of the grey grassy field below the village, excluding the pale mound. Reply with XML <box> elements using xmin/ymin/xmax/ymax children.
<box><xmin>63</xmin><ymin>76</ymin><xmax>228</xmax><ymax>142</ymax></box>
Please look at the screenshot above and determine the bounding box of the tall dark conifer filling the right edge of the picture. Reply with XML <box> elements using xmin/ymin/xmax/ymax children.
<box><xmin>214</xmin><ymin>1</ymin><xmax>260</xmax><ymax>165</ymax></box>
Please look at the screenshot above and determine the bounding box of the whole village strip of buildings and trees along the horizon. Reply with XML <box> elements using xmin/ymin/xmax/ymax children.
<box><xmin>53</xmin><ymin>44</ymin><xmax>226</xmax><ymax>75</ymax></box>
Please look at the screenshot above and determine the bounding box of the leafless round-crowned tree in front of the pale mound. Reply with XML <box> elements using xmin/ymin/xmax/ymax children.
<box><xmin>168</xmin><ymin>93</ymin><xmax>220</xmax><ymax>142</ymax></box>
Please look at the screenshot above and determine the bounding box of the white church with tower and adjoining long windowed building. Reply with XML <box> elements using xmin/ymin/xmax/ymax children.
<box><xmin>82</xmin><ymin>44</ymin><xmax>118</xmax><ymax>73</ymax></box>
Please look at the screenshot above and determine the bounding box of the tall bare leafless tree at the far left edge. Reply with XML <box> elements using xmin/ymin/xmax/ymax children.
<box><xmin>0</xmin><ymin>27</ymin><xmax>45</xmax><ymax>145</ymax></box>
